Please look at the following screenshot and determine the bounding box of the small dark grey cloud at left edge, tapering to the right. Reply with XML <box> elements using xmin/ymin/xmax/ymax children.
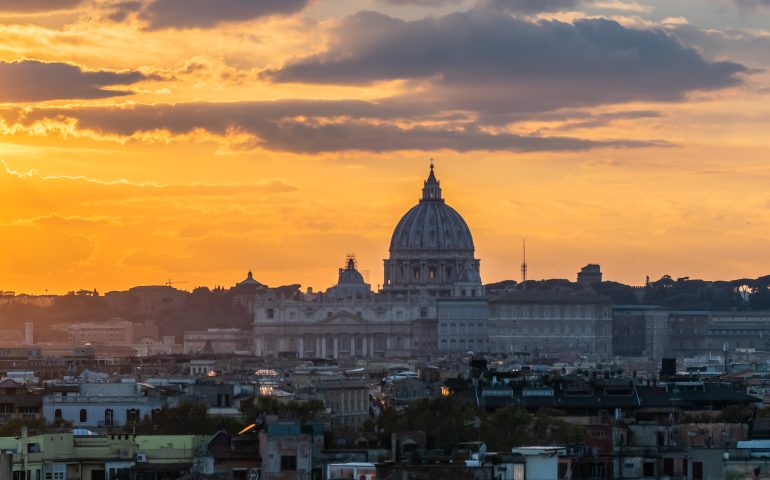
<box><xmin>0</xmin><ymin>60</ymin><xmax>145</xmax><ymax>102</ymax></box>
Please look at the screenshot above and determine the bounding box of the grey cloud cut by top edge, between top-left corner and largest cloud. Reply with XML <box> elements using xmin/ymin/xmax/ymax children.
<box><xmin>108</xmin><ymin>0</ymin><xmax>311</xmax><ymax>30</ymax></box>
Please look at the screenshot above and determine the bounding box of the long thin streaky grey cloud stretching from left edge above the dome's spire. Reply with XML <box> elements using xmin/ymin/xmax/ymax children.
<box><xmin>5</xmin><ymin>100</ymin><xmax>662</xmax><ymax>153</ymax></box>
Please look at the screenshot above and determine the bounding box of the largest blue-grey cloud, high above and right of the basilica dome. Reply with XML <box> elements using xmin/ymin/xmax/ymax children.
<box><xmin>263</xmin><ymin>8</ymin><xmax>746</xmax><ymax>113</ymax></box>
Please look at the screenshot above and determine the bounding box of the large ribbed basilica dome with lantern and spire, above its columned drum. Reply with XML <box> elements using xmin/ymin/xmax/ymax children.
<box><xmin>390</xmin><ymin>164</ymin><xmax>474</xmax><ymax>254</ymax></box>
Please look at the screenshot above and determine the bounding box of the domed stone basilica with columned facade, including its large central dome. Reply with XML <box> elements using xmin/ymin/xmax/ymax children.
<box><xmin>250</xmin><ymin>164</ymin><xmax>486</xmax><ymax>359</ymax></box>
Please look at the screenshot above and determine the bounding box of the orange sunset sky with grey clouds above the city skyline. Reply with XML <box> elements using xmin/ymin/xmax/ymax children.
<box><xmin>0</xmin><ymin>0</ymin><xmax>770</xmax><ymax>294</ymax></box>
